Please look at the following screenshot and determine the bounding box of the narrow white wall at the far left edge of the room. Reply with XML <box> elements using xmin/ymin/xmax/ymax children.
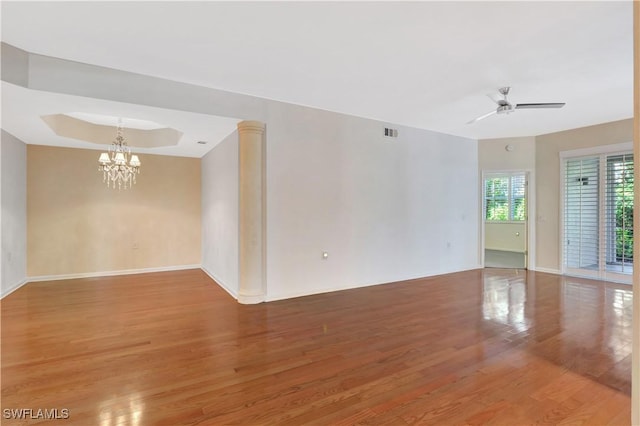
<box><xmin>0</xmin><ymin>130</ymin><xmax>27</xmax><ymax>297</ymax></box>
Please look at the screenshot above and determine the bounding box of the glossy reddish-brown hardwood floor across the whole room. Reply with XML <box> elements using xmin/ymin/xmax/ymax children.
<box><xmin>0</xmin><ymin>269</ymin><xmax>632</xmax><ymax>426</ymax></box>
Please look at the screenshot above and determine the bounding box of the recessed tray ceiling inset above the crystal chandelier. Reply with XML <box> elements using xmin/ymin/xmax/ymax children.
<box><xmin>41</xmin><ymin>113</ymin><xmax>182</xmax><ymax>148</ymax></box>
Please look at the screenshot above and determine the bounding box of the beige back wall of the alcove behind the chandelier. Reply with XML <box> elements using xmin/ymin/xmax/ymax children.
<box><xmin>27</xmin><ymin>145</ymin><xmax>201</xmax><ymax>277</ymax></box>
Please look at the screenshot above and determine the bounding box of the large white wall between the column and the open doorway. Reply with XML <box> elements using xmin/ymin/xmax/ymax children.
<box><xmin>266</xmin><ymin>104</ymin><xmax>479</xmax><ymax>300</ymax></box>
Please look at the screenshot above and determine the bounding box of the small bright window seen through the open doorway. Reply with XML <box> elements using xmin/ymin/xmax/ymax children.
<box><xmin>484</xmin><ymin>173</ymin><xmax>527</xmax><ymax>221</ymax></box>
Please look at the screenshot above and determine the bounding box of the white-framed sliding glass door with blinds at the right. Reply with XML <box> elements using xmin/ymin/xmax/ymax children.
<box><xmin>563</xmin><ymin>152</ymin><xmax>633</xmax><ymax>283</ymax></box>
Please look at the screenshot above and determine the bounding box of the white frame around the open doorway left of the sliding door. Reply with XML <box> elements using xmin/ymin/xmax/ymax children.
<box><xmin>479</xmin><ymin>169</ymin><xmax>536</xmax><ymax>270</ymax></box>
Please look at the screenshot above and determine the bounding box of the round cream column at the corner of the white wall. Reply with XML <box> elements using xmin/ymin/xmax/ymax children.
<box><xmin>238</xmin><ymin>121</ymin><xmax>265</xmax><ymax>304</ymax></box>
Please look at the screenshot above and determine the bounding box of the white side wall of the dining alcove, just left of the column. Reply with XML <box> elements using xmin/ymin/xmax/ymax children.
<box><xmin>201</xmin><ymin>131</ymin><xmax>238</xmax><ymax>298</ymax></box>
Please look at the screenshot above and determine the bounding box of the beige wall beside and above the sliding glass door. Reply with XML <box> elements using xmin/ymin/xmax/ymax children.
<box><xmin>535</xmin><ymin>119</ymin><xmax>633</xmax><ymax>271</ymax></box>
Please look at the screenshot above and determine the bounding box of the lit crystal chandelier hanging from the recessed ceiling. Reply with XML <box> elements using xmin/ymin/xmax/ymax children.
<box><xmin>98</xmin><ymin>119</ymin><xmax>141</xmax><ymax>189</ymax></box>
